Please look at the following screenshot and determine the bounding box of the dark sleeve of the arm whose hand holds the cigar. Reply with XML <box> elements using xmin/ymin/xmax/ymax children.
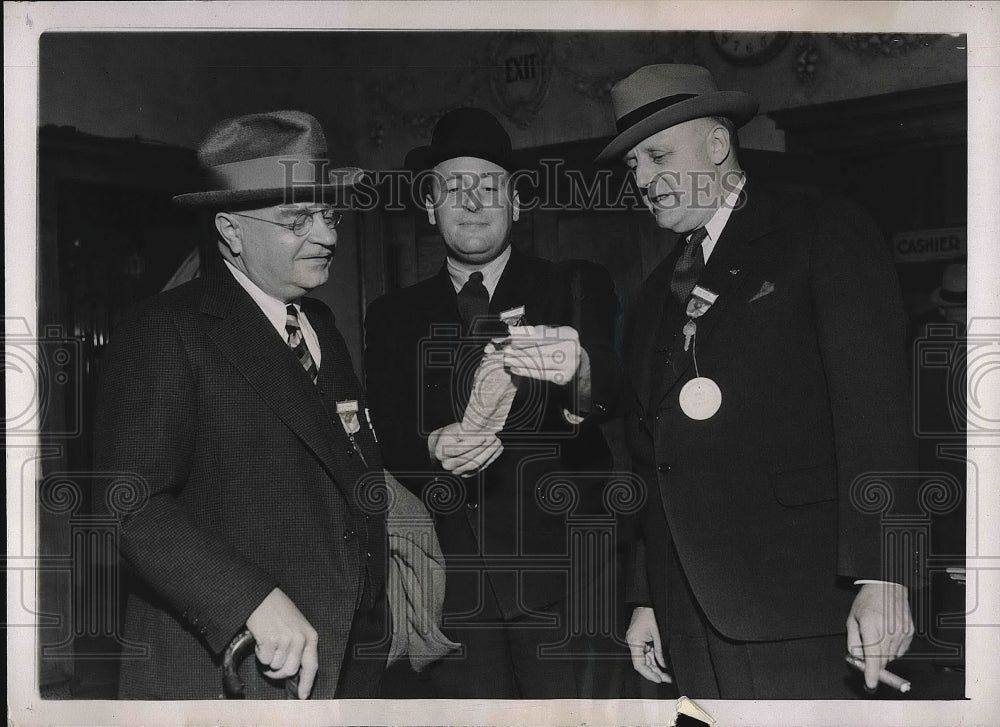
<box><xmin>810</xmin><ymin>199</ymin><xmax>916</xmax><ymax>584</ymax></box>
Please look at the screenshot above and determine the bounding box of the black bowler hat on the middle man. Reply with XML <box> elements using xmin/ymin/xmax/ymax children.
<box><xmin>403</xmin><ymin>107</ymin><xmax>512</xmax><ymax>173</ymax></box>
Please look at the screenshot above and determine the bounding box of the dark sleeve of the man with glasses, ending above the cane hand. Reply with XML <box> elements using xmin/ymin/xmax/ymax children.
<box><xmin>95</xmin><ymin>308</ymin><xmax>277</xmax><ymax>653</ymax></box>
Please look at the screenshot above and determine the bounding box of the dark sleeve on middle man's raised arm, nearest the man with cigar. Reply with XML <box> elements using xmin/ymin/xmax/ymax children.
<box><xmin>568</xmin><ymin>261</ymin><xmax>622</xmax><ymax>423</ymax></box>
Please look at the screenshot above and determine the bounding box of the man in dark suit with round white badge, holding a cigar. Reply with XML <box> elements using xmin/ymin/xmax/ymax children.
<box><xmin>599</xmin><ymin>64</ymin><xmax>915</xmax><ymax>699</ymax></box>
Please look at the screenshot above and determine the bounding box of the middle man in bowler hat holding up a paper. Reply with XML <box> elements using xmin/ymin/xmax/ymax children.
<box><xmin>365</xmin><ymin>109</ymin><xmax>620</xmax><ymax>699</ymax></box>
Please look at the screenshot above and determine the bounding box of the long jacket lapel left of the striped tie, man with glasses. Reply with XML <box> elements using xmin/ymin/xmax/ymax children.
<box><xmin>201</xmin><ymin>268</ymin><xmax>348</xmax><ymax>486</ymax></box>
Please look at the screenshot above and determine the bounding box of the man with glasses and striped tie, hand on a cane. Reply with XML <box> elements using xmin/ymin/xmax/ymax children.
<box><xmin>95</xmin><ymin>111</ymin><xmax>387</xmax><ymax>699</ymax></box>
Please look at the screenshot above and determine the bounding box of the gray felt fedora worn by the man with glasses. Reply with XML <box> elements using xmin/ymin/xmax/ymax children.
<box><xmin>174</xmin><ymin>111</ymin><xmax>364</xmax><ymax>207</ymax></box>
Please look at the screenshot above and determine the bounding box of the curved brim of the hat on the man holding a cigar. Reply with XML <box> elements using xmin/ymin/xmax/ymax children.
<box><xmin>596</xmin><ymin>91</ymin><xmax>759</xmax><ymax>163</ymax></box>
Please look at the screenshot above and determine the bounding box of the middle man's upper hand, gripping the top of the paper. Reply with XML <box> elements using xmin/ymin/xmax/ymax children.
<box><xmin>503</xmin><ymin>326</ymin><xmax>584</xmax><ymax>385</ymax></box>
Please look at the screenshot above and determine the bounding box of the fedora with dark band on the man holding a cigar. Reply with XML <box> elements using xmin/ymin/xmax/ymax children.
<box><xmin>597</xmin><ymin>63</ymin><xmax>757</xmax><ymax>162</ymax></box>
